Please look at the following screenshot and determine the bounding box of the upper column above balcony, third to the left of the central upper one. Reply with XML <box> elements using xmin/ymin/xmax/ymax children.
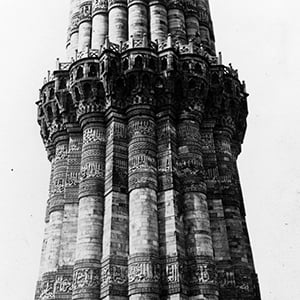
<box><xmin>78</xmin><ymin>0</ymin><xmax>92</xmax><ymax>52</ymax></box>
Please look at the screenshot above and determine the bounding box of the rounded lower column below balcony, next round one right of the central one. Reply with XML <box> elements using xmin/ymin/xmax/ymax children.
<box><xmin>178</xmin><ymin>112</ymin><xmax>219</xmax><ymax>300</ymax></box>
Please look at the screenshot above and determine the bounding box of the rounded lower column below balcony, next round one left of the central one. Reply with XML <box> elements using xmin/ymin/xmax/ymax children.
<box><xmin>72</xmin><ymin>112</ymin><xmax>106</xmax><ymax>300</ymax></box>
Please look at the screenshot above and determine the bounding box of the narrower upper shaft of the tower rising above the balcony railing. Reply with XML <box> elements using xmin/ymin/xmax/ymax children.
<box><xmin>67</xmin><ymin>0</ymin><xmax>215</xmax><ymax>59</ymax></box>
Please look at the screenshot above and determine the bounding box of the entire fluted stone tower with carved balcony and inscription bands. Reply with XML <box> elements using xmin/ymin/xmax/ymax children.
<box><xmin>35</xmin><ymin>0</ymin><xmax>260</xmax><ymax>300</ymax></box>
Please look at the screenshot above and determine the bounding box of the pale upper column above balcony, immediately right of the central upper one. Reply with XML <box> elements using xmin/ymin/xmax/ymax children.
<box><xmin>149</xmin><ymin>0</ymin><xmax>168</xmax><ymax>43</ymax></box>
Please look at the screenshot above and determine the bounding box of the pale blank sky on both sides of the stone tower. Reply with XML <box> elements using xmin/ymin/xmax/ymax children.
<box><xmin>0</xmin><ymin>0</ymin><xmax>300</xmax><ymax>300</ymax></box>
